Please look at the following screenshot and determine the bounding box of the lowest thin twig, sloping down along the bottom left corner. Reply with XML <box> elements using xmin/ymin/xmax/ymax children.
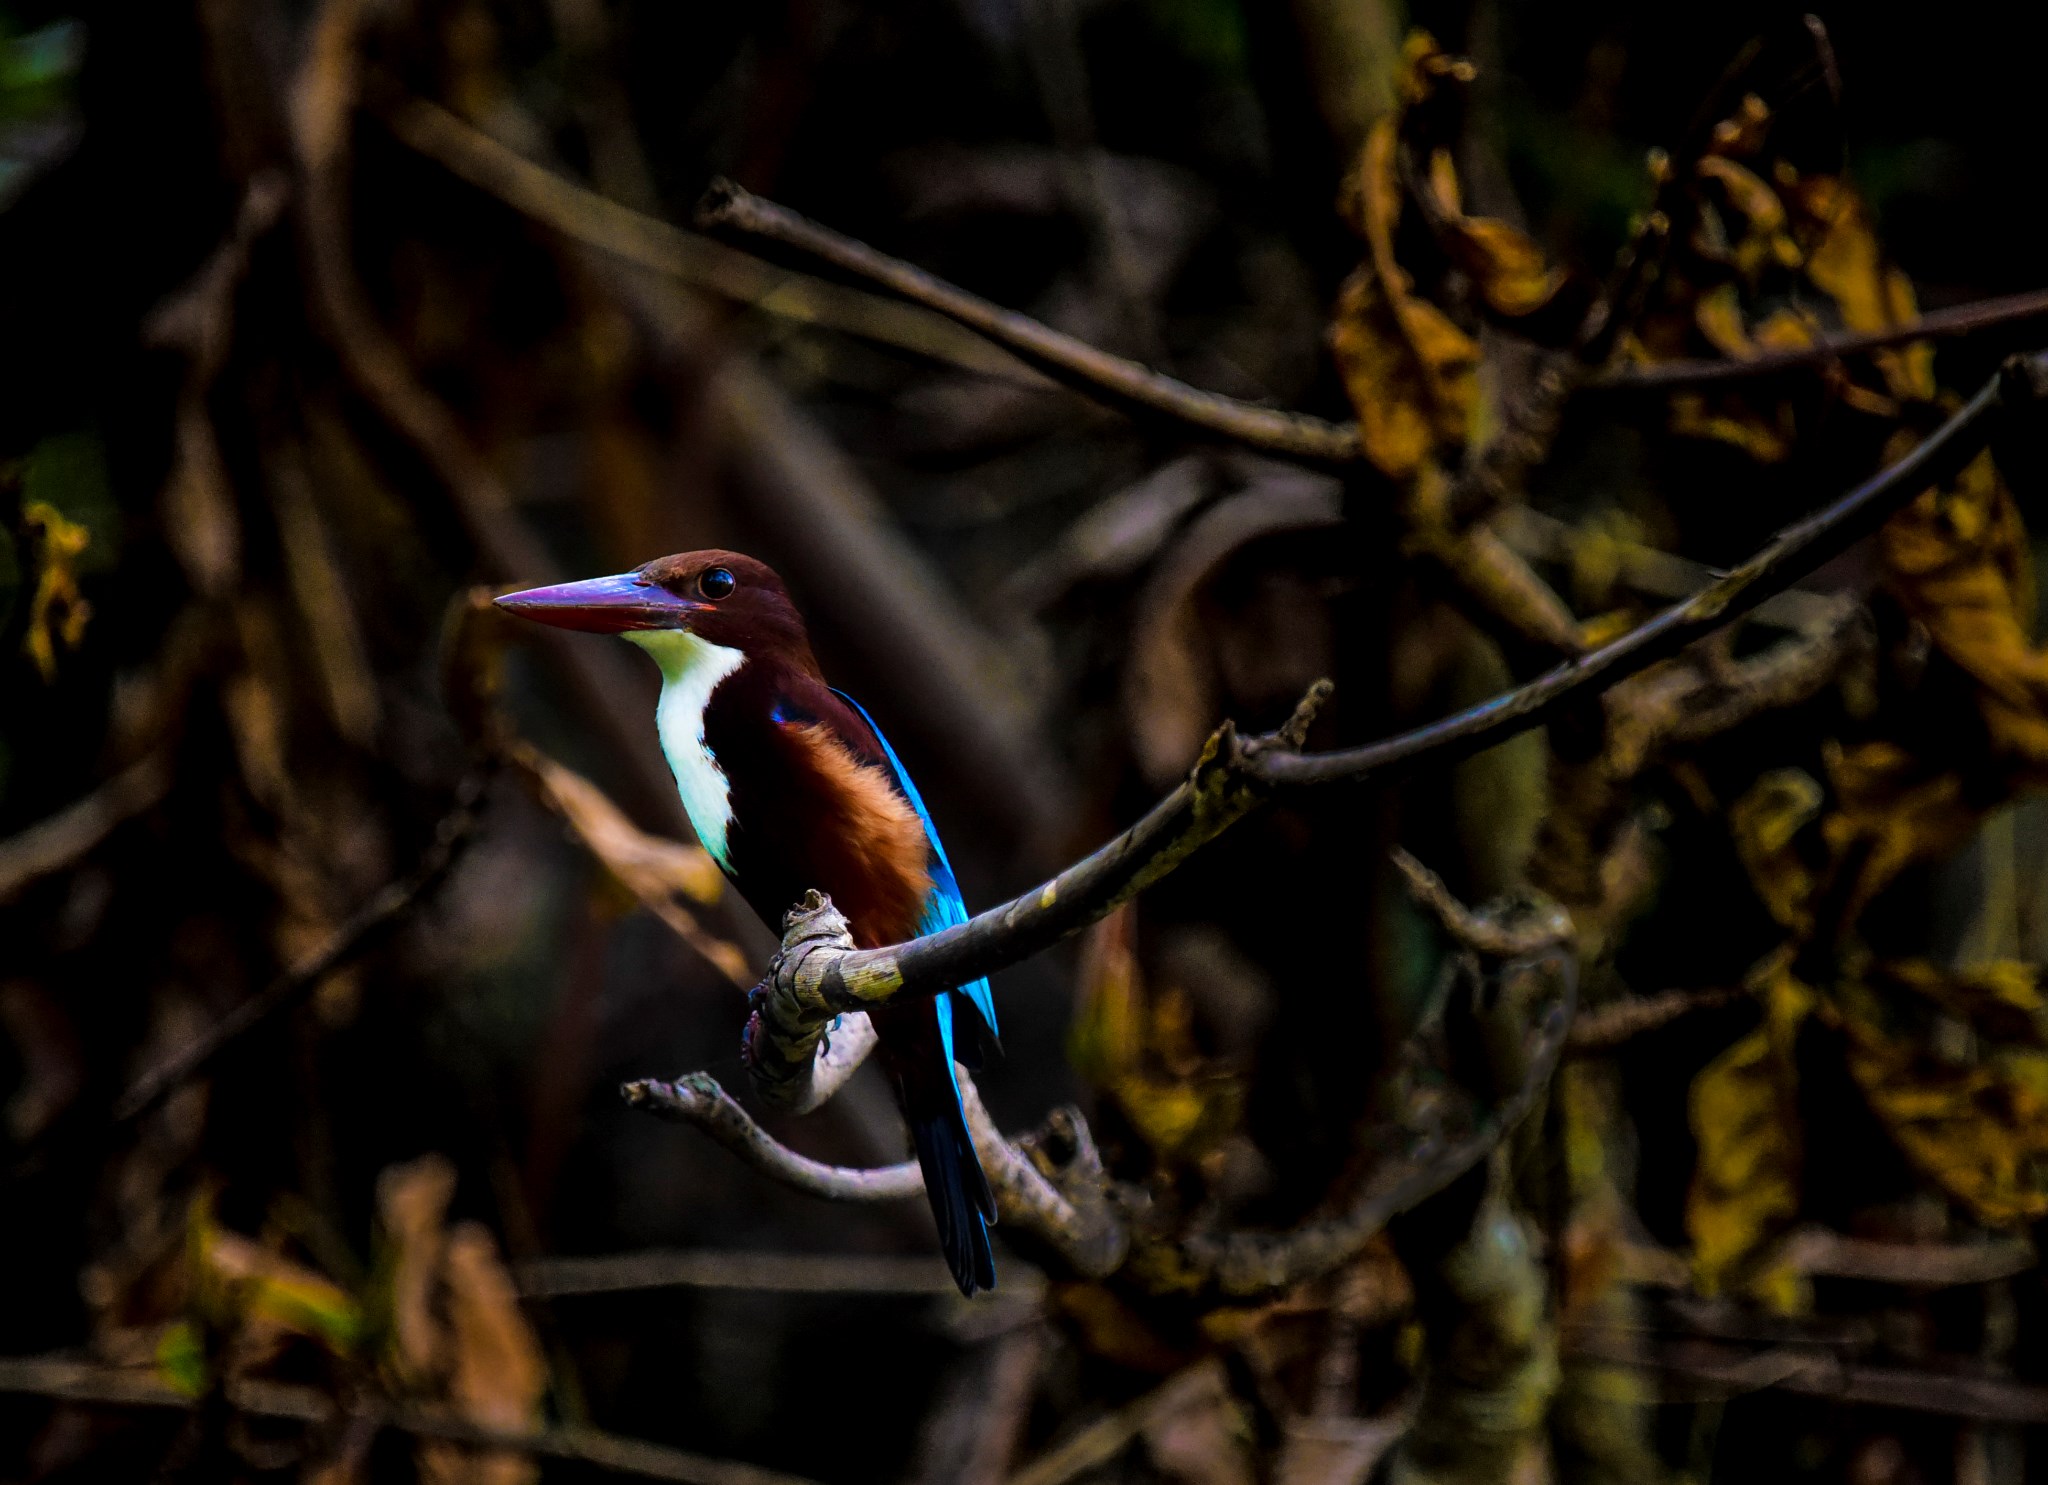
<box><xmin>0</xmin><ymin>1356</ymin><xmax>813</xmax><ymax>1485</ymax></box>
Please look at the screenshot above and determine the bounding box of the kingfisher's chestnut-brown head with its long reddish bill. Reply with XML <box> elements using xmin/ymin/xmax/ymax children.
<box><xmin>498</xmin><ymin>551</ymin><xmax>815</xmax><ymax>668</ymax></box>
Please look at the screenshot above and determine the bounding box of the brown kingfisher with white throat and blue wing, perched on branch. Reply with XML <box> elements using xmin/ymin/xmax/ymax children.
<box><xmin>498</xmin><ymin>551</ymin><xmax>995</xmax><ymax>1295</ymax></box>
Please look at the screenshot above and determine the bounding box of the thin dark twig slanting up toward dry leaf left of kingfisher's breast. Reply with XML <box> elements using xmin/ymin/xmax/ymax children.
<box><xmin>113</xmin><ymin>774</ymin><xmax>483</xmax><ymax>1125</ymax></box>
